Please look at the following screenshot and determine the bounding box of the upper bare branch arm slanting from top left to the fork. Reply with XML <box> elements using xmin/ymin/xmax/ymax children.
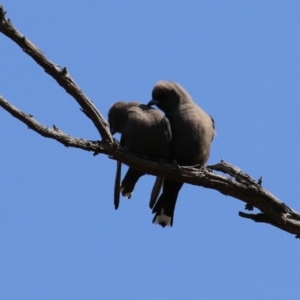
<box><xmin>0</xmin><ymin>5</ymin><xmax>113</xmax><ymax>143</ymax></box>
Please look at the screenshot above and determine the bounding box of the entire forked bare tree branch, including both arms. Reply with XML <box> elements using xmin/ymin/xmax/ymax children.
<box><xmin>0</xmin><ymin>6</ymin><xmax>300</xmax><ymax>238</ymax></box>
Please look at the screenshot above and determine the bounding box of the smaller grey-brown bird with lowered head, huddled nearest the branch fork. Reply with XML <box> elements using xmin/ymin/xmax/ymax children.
<box><xmin>108</xmin><ymin>102</ymin><xmax>171</xmax><ymax>209</ymax></box>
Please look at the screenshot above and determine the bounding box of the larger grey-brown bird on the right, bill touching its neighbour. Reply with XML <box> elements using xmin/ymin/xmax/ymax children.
<box><xmin>148</xmin><ymin>81</ymin><xmax>215</xmax><ymax>227</ymax></box>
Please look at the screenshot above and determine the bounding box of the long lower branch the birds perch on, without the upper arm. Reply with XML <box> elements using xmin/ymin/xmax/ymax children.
<box><xmin>0</xmin><ymin>97</ymin><xmax>300</xmax><ymax>237</ymax></box>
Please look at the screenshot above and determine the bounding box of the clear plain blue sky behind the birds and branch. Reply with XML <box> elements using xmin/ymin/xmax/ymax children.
<box><xmin>0</xmin><ymin>0</ymin><xmax>300</xmax><ymax>300</ymax></box>
